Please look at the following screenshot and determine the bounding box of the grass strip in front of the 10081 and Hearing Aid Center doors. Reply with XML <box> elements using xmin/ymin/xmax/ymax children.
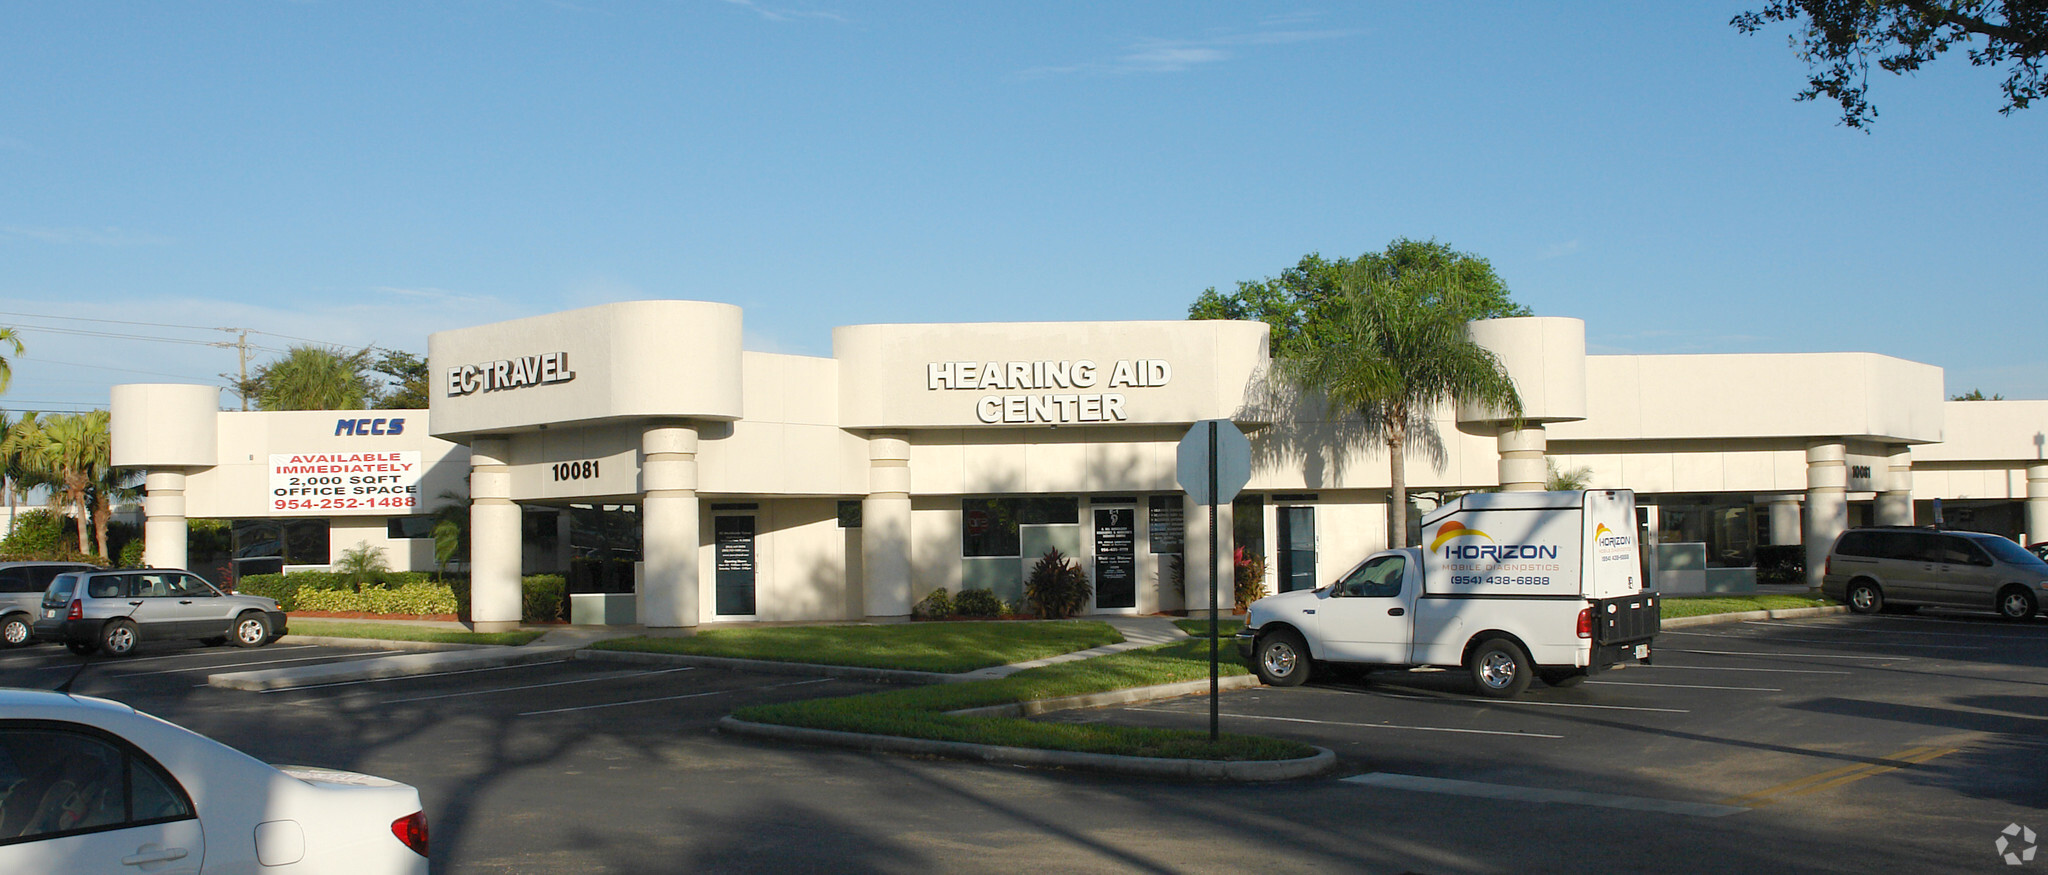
<box><xmin>592</xmin><ymin>621</ymin><xmax>1124</xmax><ymax>674</ymax></box>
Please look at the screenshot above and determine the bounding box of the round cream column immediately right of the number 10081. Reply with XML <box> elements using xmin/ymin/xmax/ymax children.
<box><xmin>639</xmin><ymin>424</ymin><xmax>702</xmax><ymax>629</ymax></box>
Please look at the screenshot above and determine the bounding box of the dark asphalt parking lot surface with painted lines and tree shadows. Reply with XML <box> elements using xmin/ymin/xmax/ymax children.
<box><xmin>0</xmin><ymin>613</ymin><xmax>2048</xmax><ymax>873</ymax></box>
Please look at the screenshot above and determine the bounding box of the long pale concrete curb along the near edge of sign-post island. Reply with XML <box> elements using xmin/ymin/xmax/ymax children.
<box><xmin>719</xmin><ymin>717</ymin><xmax>1337</xmax><ymax>781</ymax></box>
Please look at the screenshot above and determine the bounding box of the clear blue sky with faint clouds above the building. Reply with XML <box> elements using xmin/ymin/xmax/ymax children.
<box><xmin>0</xmin><ymin>0</ymin><xmax>2048</xmax><ymax>410</ymax></box>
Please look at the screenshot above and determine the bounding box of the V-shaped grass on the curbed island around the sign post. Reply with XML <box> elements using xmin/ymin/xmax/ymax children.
<box><xmin>733</xmin><ymin>639</ymin><xmax>1315</xmax><ymax>760</ymax></box>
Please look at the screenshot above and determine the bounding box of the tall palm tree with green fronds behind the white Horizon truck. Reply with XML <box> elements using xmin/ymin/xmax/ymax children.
<box><xmin>1278</xmin><ymin>266</ymin><xmax>1522</xmax><ymax>547</ymax></box>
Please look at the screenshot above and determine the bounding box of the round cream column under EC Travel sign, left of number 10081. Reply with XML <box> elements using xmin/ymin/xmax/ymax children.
<box><xmin>469</xmin><ymin>436</ymin><xmax>520</xmax><ymax>631</ymax></box>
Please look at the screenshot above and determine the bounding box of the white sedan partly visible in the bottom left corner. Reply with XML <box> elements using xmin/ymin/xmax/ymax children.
<box><xmin>0</xmin><ymin>689</ymin><xmax>428</xmax><ymax>875</ymax></box>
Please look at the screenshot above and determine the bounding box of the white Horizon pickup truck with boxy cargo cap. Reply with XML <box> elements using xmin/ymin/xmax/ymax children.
<box><xmin>1237</xmin><ymin>490</ymin><xmax>1659</xmax><ymax>699</ymax></box>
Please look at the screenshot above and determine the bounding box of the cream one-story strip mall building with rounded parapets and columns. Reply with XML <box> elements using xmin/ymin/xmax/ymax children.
<box><xmin>113</xmin><ymin>301</ymin><xmax>2048</xmax><ymax>627</ymax></box>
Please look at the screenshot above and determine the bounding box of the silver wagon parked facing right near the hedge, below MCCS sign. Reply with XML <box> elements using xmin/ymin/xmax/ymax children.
<box><xmin>35</xmin><ymin>568</ymin><xmax>287</xmax><ymax>656</ymax></box>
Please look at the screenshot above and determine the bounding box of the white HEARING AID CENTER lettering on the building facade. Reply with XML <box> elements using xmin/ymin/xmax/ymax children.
<box><xmin>924</xmin><ymin>359</ymin><xmax>1174</xmax><ymax>424</ymax></box>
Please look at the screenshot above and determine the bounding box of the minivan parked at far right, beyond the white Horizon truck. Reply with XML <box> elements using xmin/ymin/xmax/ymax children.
<box><xmin>1821</xmin><ymin>527</ymin><xmax>2048</xmax><ymax>619</ymax></box>
